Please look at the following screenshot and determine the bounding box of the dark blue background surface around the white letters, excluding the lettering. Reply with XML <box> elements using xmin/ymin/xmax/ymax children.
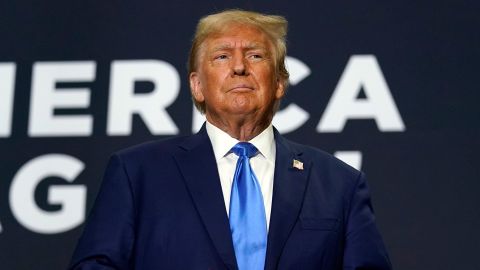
<box><xmin>0</xmin><ymin>0</ymin><xmax>480</xmax><ymax>270</ymax></box>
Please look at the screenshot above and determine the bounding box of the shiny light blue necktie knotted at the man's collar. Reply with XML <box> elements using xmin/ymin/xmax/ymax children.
<box><xmin>229</xmin><ymin>142</ymin><xmax>267</xmax><ymax>270</ymax></box>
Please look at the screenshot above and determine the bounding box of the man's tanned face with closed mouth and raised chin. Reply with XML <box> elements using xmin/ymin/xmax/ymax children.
<box><xmin>190</xmin><ymin>25</ymin><xmax>284</xmax><ymax>124</ymax></box>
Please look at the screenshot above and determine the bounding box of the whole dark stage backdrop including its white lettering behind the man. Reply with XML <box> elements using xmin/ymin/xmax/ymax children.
<box><xmin>0</xmin><ymin>0</ymin><xmax>480</xmax><ymax>270</ymax></box>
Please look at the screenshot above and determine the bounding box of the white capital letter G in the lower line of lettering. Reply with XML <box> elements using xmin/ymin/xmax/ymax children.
<box><xmin>10</xmin><ymin>154</ymin><xmax>87</xmax><ymax>234</ymax></box>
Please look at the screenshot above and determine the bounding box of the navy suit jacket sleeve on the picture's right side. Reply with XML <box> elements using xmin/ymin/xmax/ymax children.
<box><xmin>343</xmin><ymin>173</ymin><xmax>392</xmax><ymax>270</ymax></box>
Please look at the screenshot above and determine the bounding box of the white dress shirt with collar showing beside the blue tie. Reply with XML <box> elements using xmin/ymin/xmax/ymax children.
<box><xmin>206</xmin><ymin>121</ymin><xmax>276</xmax><ymax>229</ymax></box>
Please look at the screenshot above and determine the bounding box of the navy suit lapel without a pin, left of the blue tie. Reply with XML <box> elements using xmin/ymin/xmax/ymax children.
<box><xmin>175</xmin><ymin>125</ymin><xmax>237</xmax><ymax>269</ymax></box>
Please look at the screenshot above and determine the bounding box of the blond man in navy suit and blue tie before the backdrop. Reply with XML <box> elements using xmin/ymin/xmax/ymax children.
<box><xmin>71</xmin><ymin>10</ymin><xmax>391</xmax><ymax>270</ymax></box>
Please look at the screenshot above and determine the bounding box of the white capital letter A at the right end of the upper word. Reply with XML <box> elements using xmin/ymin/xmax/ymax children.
<box><xmin>317</xmin><ymin>55</ymin><xmax>405</xmax><ymax>132</ymax></box>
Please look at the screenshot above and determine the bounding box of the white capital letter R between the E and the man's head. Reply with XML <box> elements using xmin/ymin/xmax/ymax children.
<box><xmin>107</xmin><ymin>60</ymin><xmax>180</xmax><ymax>136</ymax></box>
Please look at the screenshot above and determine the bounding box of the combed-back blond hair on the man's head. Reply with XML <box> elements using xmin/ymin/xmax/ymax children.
<box><xmin>188</xmin><ymin>9</ymin><xmax>289</xmax><ymax>113</ymax></box>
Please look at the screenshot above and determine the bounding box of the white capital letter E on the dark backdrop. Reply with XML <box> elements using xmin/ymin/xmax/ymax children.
<box><xmin>28</xmin><ymin>61</ymin><xmax>96</xmax><ymax>137</ymax></box>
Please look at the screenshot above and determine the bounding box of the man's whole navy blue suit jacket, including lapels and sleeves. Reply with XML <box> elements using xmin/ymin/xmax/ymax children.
<box><xmin>70</xmin><ymin>127</ymin><xmax>391</xmax><ymax>270</ymax></box>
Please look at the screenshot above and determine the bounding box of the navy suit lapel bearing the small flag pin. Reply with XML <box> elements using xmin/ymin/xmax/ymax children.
<box><xmin>265</xmin><ymin>130</ymin><xmax>310</xmax><ymax>269</ymax></box>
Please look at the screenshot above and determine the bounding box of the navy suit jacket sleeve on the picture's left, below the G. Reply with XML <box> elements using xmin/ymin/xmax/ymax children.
<box><xmin>70</xmin><ymin>155</ymin><xmax>135</xmax><ymax>270</ymax></box>
